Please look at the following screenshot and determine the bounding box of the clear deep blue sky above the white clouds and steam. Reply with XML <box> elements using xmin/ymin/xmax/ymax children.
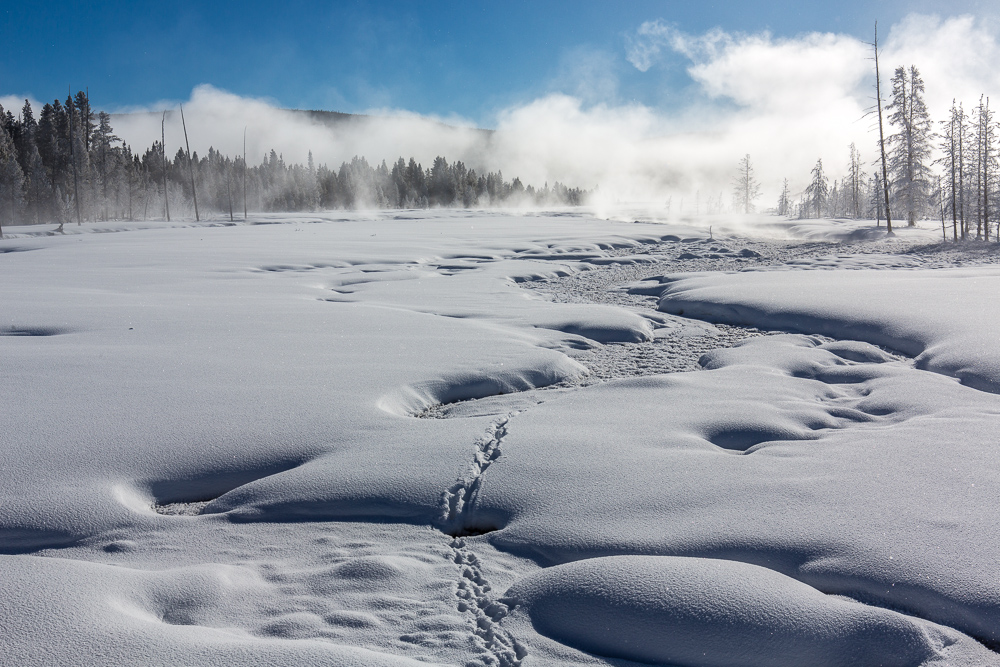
<box><xmin>0</xmin><ymin>0</ymin><xmax>995</xmax><ymax>126</ymax></box>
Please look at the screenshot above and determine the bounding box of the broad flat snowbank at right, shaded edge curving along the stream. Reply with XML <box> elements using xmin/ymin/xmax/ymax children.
<box><xmin>660</xmin><ymin>267</ymin><xmax>1000</xmax><ymax>393</ymax></box>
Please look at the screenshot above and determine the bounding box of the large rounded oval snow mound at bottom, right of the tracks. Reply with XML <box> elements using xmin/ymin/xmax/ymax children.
<box><xmin>505</xmin><ymin>556</ymin><xmax>952</xmax><ymax>667</ymax></box>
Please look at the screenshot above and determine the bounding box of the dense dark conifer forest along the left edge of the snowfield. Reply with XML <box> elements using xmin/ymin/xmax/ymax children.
<box><xmin>0</xmin><ymin>91</ymin><xmax>586</xmax><ymax>232</ymax></box>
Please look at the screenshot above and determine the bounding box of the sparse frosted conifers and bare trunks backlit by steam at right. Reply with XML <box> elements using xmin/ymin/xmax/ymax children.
<box><xmin>733</xmin><ymin>52</ymin><xmax>1000</xmax><ymax>241</ymax></box>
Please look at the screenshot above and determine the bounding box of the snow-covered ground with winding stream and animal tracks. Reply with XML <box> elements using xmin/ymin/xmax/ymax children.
<box><xmin>0</xmin><ymin>210</ymin><xmax>1000</xmax><ymax>667</ymax></box>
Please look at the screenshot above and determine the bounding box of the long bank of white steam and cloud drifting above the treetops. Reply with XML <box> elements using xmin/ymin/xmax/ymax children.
<box><xmin>103</xmin><ymin>15</ymin><xmax>1000</xmax><ymax>210</ymax></box>
